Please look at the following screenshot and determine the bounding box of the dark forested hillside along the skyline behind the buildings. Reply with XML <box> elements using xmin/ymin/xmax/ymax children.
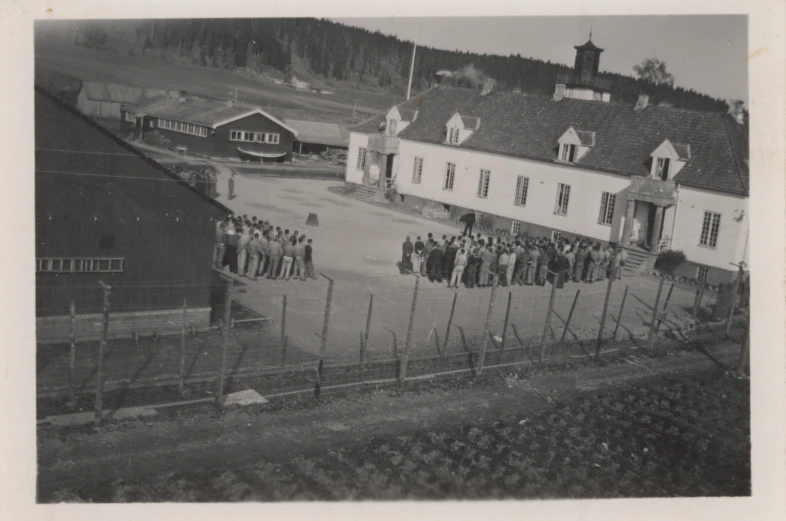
<box><xmin>41</xmin><ymin>18</ymin><xmax>726</xmax><ymax>111</ymax></box>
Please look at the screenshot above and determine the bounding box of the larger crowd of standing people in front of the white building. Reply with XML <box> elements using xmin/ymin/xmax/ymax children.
<box><xmin>400</xmin><ymin>232</ymin><xmax>627</xmax><ymax>288</ymax></box>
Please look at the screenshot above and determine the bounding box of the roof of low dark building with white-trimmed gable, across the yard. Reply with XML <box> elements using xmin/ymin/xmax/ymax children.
<box><xmin>123</xmin><ymin>96</ymin><xmax>297</xmax><ymax>135</ymax></box>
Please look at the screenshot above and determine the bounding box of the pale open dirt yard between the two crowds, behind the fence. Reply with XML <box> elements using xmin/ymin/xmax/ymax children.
<box><xmin>205</xmin><ymin>173</ymin><xmax>694</xmax><ymax>361</ymax></box>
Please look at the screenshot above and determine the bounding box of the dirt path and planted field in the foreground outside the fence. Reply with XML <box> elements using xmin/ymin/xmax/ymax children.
<box><xmin>38</xmin><ymin>343</ymin><xmax>749</xmax><ymax>502</ymax></box>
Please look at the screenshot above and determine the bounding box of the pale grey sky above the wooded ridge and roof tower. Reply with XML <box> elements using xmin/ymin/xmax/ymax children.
<box><xmin>334</xmin><ymin>15</ymin><xmax>748</xmax><ymax>104</ymax></box>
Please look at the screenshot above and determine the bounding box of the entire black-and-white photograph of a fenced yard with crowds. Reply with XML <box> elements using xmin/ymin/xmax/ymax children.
<box><xmin>4</xmin><ymin>3</ymin><xmax>784</xmax><ymax>519</ymax></box>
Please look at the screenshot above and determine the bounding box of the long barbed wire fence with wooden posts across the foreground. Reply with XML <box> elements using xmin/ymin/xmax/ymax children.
<box><xmin>37</xmin><ymin>264</ymin><xmax>749</xmax><ymax>423</ymax></box>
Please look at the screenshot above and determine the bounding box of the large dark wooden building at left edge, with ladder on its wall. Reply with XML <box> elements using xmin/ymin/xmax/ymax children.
<box><xmin>35</xmin><ymin>87</ymin><xmax>229</xmax><ymax>343</ymax></box>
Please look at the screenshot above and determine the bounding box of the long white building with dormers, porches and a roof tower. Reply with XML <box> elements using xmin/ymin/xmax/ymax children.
<box><xmin>346</xmin><ymin>35</ymin><xmax>748</xmax><ymax>283</ymax></box>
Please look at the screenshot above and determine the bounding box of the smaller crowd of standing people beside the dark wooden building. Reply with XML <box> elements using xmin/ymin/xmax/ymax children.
<box><xmin>213</xmin><ymin>215</ymin><xmax>317</xmax><ymax>281</ymax></box>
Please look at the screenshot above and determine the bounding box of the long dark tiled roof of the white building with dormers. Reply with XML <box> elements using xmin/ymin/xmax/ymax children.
<box><xmin>351</xmin><ymin>86</ymin><xmax>748</xmax><ymax>194</ymax></box>
